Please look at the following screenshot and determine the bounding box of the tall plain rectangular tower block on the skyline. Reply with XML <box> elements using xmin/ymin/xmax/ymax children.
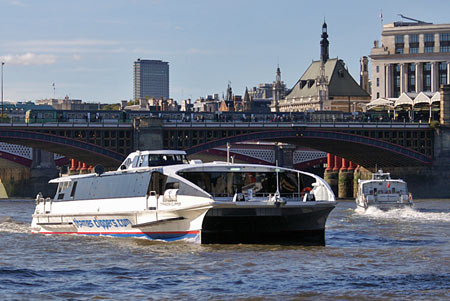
<box><xmin>134</xmin><ymin>59</ymin><xmax>169</xmax><ymax>99</ymax></box>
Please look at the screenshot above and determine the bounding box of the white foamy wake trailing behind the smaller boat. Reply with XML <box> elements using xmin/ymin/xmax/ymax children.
<box><xmin>355</xmin><ymin>207</ymin><xmax>450</xmax><ymax>222</ymax></box>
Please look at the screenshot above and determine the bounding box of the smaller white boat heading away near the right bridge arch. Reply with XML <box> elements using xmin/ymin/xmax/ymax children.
<box><xmin>356</xmin><ymin>170</ymin><xmax>413</xmax><ymax>210</ymax></box>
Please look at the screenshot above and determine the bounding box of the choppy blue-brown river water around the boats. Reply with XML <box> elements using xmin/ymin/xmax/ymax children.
<box><xmin>0</xmin><ymin>200</ymin><xmax>450</xmax><ymax>300</ymax></box>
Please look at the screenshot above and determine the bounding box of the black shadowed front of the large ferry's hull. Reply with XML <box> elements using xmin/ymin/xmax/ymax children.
<box><xmin>201</xmin><ymin>204</ymin><xmax>335</xmax><ymax>246</ymax></box>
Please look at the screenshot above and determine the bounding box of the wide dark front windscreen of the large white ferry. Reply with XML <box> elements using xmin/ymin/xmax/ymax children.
<box><xmin>179</xmin><ymin>171</ymin><xmax>303</xmax><ymax>197</ymax></box>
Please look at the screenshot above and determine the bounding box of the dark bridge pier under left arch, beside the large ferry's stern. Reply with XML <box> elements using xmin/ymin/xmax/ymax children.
<box><xmin>27</xmin><ymin>148</ymin><xmax>58</xmax><ymax>197</ymax></box>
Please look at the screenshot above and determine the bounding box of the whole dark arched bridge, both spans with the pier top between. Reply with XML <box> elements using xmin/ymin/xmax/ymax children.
<box><xmin>0</xmin><ymin>118</ymin><xmax>434</xmax><ymax>168</ymax></box>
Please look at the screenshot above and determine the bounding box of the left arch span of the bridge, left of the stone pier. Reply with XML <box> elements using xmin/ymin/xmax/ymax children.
<box><xmin>0</xmin><ymin>123</ymin><xmax>133</xmax><ymax>167</ymax></box>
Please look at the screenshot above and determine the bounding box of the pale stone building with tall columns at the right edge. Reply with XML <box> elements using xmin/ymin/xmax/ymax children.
<box><xmin>370</xmin><ymin>21</ymin><xmax>450</xmax><ymax>99</ymax></box>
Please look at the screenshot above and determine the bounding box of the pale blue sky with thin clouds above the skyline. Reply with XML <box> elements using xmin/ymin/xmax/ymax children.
<box><xmin>0</xmin><ymin>0</ymin><xmax>450</xmax><ymax>103</ymax></box>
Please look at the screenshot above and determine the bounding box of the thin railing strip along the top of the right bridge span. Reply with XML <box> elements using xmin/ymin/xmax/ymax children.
<box><xmin>163</xmin><ymin>120</ymin><xmax>430</xmax><ymax>129</ymax></box>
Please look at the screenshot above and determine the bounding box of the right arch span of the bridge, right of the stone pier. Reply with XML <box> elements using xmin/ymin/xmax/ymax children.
<box><xmin>162</xmin><ymin>122</ymin><xmax>434</xmax><ymax>168</ymax></box>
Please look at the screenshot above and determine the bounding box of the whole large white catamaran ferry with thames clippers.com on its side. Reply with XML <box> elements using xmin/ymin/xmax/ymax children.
<box><xmin>32</xmin><ymin>150</ymin><xmax>336</xmax><ymax>245</ymax></box>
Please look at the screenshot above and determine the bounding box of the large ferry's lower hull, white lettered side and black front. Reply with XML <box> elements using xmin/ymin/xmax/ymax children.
<box><xmin>33</xmin><ymin>203</ymin><xmax>334</xmax><ymax>245</ymax></box>
